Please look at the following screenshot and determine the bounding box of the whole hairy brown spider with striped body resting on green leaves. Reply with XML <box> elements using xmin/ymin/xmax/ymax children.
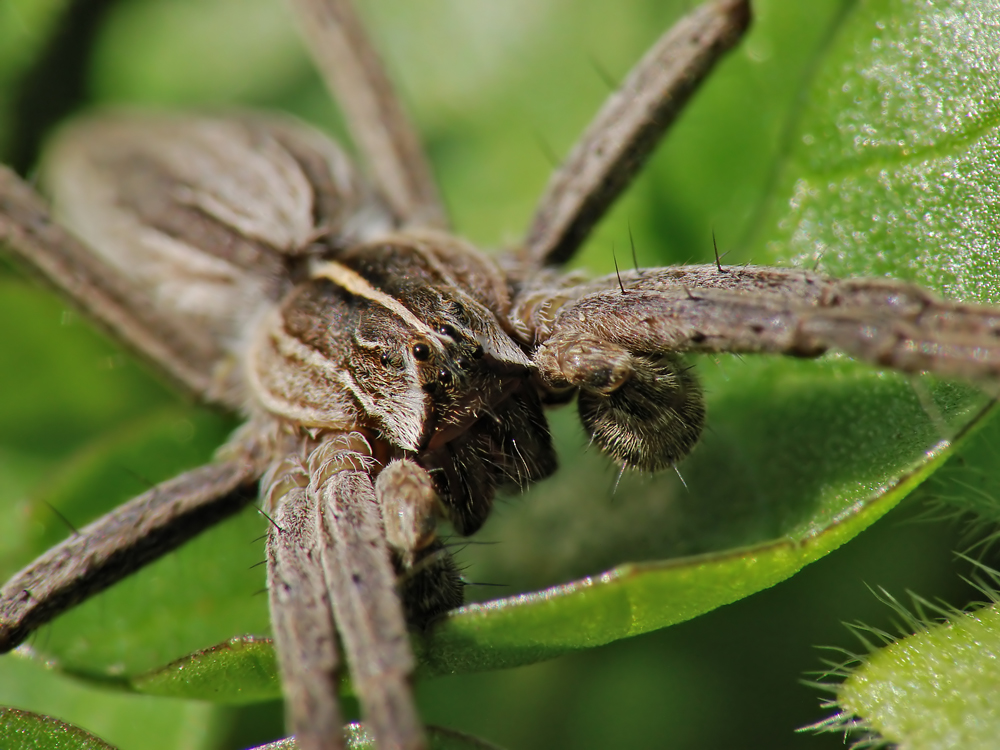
<box><xmin>0</xmin><ymin>0</ymin><xmax>1000</xmax><ymax>748</ymax></box>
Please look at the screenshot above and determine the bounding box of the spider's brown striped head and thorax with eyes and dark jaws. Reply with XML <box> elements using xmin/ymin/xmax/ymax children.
<box><xmin>247</xmin><ymin>233</ymin><xmax>555</xmax><ymax>535</ymax></box>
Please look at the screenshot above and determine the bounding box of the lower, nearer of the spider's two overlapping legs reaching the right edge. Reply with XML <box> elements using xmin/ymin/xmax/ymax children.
<box><xmin>548</xmin><ymin>279</ymin><xmax>1000</xmax><ymax>381</ymax></box>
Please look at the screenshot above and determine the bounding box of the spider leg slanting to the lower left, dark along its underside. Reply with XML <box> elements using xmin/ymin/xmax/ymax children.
<box><xmin>0</xmin><ymin>456</ymin><xmax>260</xmax><ymax>653</ymax></box>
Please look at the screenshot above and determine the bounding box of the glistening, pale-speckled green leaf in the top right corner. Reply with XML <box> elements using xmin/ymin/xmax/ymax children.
<box><xmin>758</xmin><ymin>0</ymin><xmax>1000</xmax><ymax>302</ymax></box>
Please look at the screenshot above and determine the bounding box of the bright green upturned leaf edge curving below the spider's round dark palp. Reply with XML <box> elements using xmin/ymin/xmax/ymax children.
<box><xmin>419</xmin><ymin>390</ymin><xmax>992</xmax><ymax>674</ymax></box>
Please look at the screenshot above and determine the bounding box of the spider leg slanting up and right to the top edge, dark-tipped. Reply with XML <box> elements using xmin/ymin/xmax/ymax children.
<box><xmin>524</xmin><ymin>0</ymin><xmax>750</xmax><ymax>268</ymax></box>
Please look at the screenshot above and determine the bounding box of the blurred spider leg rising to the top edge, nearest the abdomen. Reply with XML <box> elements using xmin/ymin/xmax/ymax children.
<box><xmin>292</xmin><ymin>0</ymin><xmax>447</xmax><ymax>227</ymax></box>
